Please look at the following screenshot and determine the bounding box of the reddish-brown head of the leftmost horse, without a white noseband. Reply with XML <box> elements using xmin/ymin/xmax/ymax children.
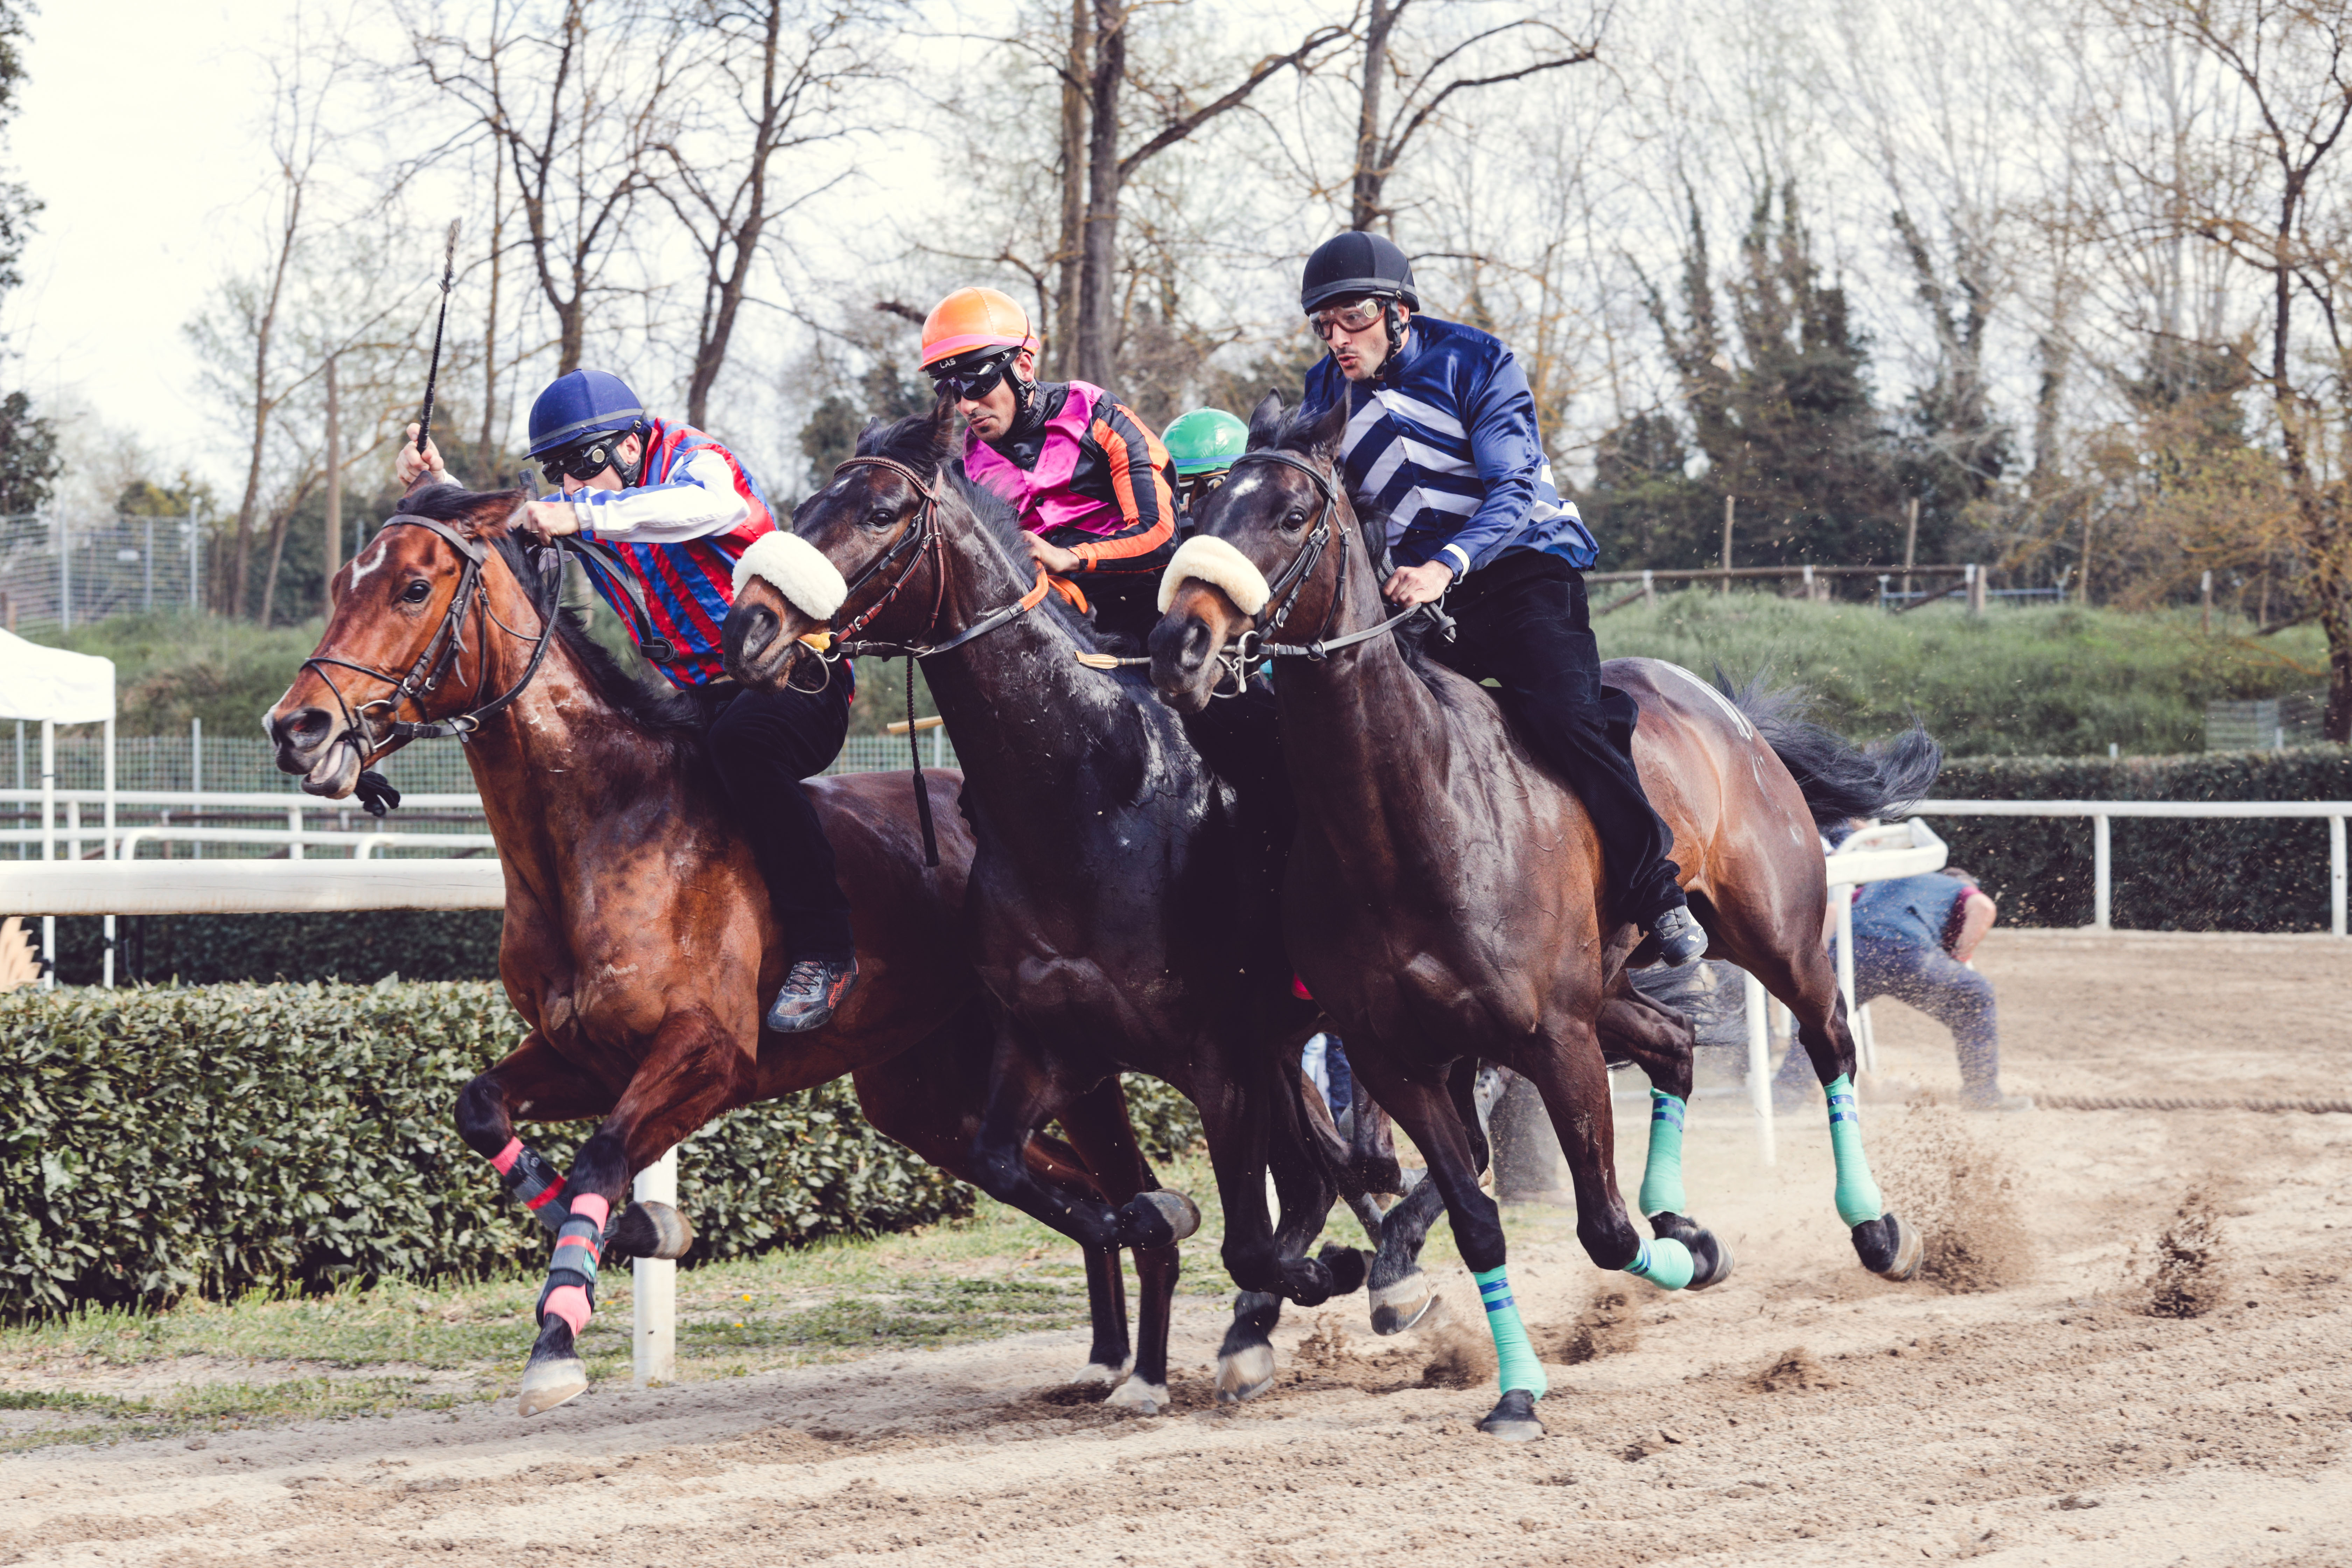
<box><xmin>261</xmin><ymin>486</ymin><xmax>539</xmax><ymax>799</ymax></box>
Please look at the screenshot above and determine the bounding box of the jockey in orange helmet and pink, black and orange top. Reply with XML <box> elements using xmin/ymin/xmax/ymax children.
<box><xmin>922</xmin><ymin>289</ymin><xmax>1176</xmax><ymax>632</ymax></box>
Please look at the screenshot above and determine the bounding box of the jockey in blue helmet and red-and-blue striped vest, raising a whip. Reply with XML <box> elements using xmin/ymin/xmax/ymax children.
<box><xmin>398</xmin><ymin>369</ymin><xmax>859</xmax><ymax>1034</ymax></box>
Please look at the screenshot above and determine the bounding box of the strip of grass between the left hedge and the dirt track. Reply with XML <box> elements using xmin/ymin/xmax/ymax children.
<box><xmin>0</xmin><ymin>1154</ymin><xmax>1392</xmax><ymax>1453</ymax></box>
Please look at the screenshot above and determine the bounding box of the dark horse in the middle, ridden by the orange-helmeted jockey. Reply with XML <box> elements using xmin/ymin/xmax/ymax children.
<box><xmin>727</xmin><ymin>402</ymin><xmax>1364</xmax><ymax>1408</ymax></box>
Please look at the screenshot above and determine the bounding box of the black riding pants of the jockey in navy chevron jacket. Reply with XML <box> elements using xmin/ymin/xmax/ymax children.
<box><xmin>1421</xmin><ymin>550</ymin><xmax>1684</xmax><ymax>926</ymax></box>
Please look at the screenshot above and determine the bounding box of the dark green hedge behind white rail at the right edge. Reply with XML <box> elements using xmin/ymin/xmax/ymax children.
<box><xmin>1933</xmin><ymin>745</ymin><xmax>2352</xmax><ymax>931</ymax></box>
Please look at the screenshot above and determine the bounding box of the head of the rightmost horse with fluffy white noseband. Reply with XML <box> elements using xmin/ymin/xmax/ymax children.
<box><xmin>1150</xmin><ymin>393</ymin><xmax>1371</xmax><ymax>712</ymax></box>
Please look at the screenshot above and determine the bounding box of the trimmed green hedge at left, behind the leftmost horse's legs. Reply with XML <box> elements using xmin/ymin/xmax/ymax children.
<box><xmin>0</xmin><ymin>983</ymin><xmax>1197</xmax><ymax>1316</ymax></box>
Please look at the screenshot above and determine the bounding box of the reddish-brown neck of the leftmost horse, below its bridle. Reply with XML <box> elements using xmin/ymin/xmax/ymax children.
<box><xmin>451</xmin><ymin>552</ymin><xmax>680</xmax><ymax>882</ymax></box>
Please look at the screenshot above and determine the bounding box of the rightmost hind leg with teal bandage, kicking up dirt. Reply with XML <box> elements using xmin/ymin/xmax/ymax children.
<box><xmin>1719</xmin><ymin>926</ymin><xmax>1926</xmax><ymax>1281</ymax></box>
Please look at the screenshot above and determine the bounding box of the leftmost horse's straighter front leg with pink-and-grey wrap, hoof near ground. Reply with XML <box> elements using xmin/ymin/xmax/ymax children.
<box><xmin>522</xmin><ymin>1006</ymin><xmax>755</xmax><ymax>1415</ymax></box>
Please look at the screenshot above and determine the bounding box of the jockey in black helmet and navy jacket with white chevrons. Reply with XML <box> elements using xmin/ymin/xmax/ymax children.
<box><xmin>1298</xmin><ymin>233</ymin><xmax>1708</xmax><ymax>964</ymax></box>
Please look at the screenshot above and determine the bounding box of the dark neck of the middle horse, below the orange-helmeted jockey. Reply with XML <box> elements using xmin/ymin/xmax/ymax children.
<box><xmin>922</xmin><ymin>500</ymin><xmax>1167</xmax><ymax>860</ymax></box>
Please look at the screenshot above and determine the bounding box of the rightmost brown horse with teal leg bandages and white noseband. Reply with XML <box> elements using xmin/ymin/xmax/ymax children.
<box><xmin>1150</xmin><ymin>397</ymin><xmax>1940</xmax><ymax>1439</ymax></box>
